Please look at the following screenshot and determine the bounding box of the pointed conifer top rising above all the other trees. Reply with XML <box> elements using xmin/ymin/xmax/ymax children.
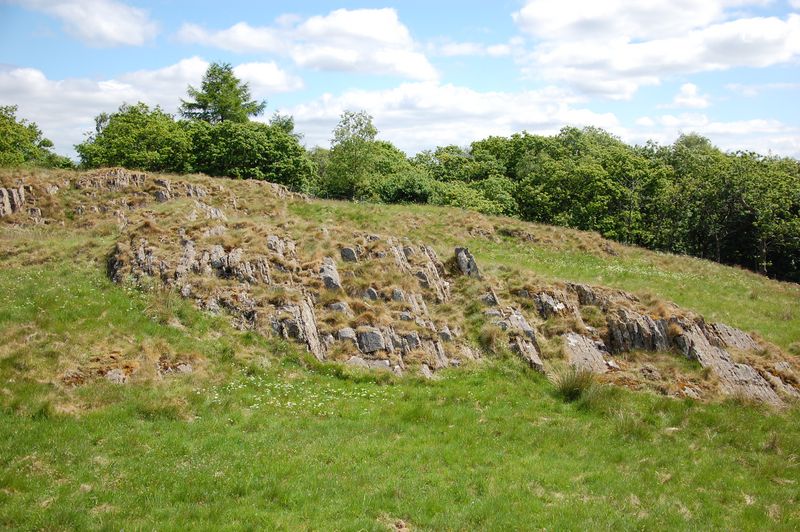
<box><xmin>180</xmin><ymin>63</ymin><xmax>266</xmax><ymax>124</ymax></box>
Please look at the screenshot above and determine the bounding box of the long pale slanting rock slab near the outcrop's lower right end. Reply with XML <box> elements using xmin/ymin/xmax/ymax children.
<box><xmin>675</xmin><ymin>324</ymin><xmax>782</xmax><ymax>405</ymax></box>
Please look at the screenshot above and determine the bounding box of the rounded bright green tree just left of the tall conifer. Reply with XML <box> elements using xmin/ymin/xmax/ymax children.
<box><xmin>75</xmin><ymin>102</ymin><xmax>192</xmax><ymax>172</ymax></box>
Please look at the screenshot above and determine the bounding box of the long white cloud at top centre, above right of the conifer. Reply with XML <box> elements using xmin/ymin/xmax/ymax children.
<box><xmin>177</xmin><ymin>8</ymin><xmax>437</xmax><ymax>80</ymax></box>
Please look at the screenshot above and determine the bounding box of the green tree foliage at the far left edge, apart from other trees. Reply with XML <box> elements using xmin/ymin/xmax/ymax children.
<box><xmin>0</xmin><ymin>105</ymin><xmax>72</xmax><ymax>168</ymax></box>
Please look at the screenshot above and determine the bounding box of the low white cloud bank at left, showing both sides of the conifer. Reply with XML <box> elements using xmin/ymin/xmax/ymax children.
<box><xmin>0</xmin><ymin>57</ymin><xmax>302</xmax><ymax>155</ymax></box>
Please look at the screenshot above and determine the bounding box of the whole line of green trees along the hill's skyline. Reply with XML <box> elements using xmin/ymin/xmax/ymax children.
<box><xmin>0</xmin><ymin>63</ymin><xmax>800</xmax><ymax>282</ymax></box>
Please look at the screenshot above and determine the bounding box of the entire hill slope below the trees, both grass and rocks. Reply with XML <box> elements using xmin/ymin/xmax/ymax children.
<box><xmin>0</xmin><ymin>170</ymin><xmax>800</xmax><ymax>529</ymax></box>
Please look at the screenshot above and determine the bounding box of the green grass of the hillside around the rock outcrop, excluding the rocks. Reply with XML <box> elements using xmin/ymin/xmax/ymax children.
<box><xmin>0</xmin><ymin>171</ymin><xmax>800</xmax><ymax>530</ymax></box>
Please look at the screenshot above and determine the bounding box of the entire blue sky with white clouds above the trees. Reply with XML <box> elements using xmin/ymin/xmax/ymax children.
<box><xmin>0</xmin><ymin>0</ymin><xmax>800</xmax><ymax>158</ymax></box>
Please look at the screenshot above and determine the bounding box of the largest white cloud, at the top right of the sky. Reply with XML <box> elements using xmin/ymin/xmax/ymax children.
<box><xmin>514</xmin><ymin>0</ymin><xmax>800</xmax><ymax>99</ymax></box>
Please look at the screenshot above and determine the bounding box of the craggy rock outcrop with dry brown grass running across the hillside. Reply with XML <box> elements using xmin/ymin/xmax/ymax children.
<box><xmin>0</xmin><ymin>169</ymin><xmax>800</xmax><ymax>405</ymax></box>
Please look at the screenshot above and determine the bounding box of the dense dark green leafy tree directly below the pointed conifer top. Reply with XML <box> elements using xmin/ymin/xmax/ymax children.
<box><xmin>186</xmin><ymin>122</ymin><xmax>313</xmax><ymax>191</ymax></box>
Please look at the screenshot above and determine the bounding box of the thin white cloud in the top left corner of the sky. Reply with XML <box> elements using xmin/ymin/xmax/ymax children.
<box><xmin>10</xmin><ymin>0</ymin><xmax>158</xmax><ymax>47</ymax></box>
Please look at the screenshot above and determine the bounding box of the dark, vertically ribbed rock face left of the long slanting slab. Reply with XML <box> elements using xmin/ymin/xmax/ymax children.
<box><xmin>606</xmin><ymin>308</ymin><xmax>670</xmax><ymax>353</ymax></box>
